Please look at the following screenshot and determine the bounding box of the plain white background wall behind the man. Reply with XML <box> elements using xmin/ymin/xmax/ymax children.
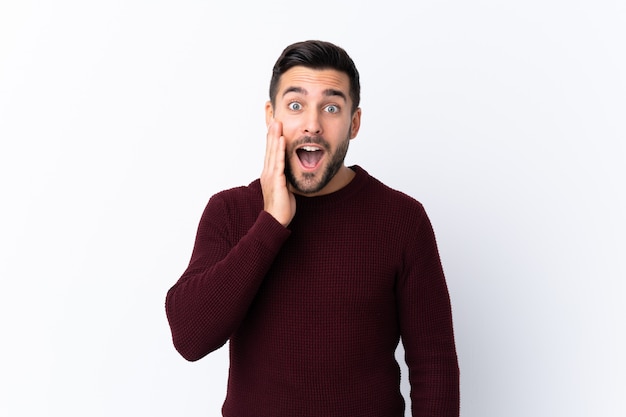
<box><xmin>0</xmin><ymin>0</ymin><xmax>626</xmax><ymax>417</ymax></box>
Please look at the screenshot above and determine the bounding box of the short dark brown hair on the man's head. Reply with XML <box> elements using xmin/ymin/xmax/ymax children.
<box><xmin>270</xmin><ymin>40</ymin><xmax>361</xmax><ymax>113</ymax></box>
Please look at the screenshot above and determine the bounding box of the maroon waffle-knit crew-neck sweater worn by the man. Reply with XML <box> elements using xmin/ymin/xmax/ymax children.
<box><xmin>166</xmin><ymin>166</ymin><xmax>459</xmax><ymax>417</ymax></box>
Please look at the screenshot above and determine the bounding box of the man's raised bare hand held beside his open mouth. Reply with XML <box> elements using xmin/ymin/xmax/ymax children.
<box><xmin>261</xmin><ymin>121</ymin><xmax>296</xmax><ymax>227</ymax></box>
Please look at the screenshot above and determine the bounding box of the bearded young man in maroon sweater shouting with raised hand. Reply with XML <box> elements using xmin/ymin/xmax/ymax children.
<box><xmin>166</xmin><ymin>41</ymin><xmax>459</xmax><ymax>417</ymax></box>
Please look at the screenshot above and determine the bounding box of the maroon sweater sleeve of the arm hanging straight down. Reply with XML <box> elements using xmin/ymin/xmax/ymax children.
<box><xmin>397</xmin><ymin>209</ymin><xmax>460</xmax><ymax>417</ymax></box>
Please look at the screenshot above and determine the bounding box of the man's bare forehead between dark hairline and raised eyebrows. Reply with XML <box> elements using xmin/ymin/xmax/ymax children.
<box><xmin>277</xmin><ymin>66</ymin><xmax>350</xmax><ymax>99</ymax></box>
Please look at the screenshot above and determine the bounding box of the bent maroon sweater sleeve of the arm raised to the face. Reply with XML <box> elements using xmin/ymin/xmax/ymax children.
<box><xmin>165</xmin><ymin>194</ymin><xmax>290</xmax><ymax>361</ymax></box>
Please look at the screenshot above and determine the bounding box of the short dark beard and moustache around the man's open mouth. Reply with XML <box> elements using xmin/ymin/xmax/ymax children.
<box><xmin>285</xmin><ymin>132</ymin><xmax>350</xmax><ymax>195</ymax></box>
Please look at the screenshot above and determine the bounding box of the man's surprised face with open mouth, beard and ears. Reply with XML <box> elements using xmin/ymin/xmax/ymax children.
<box><xmin>266</xmin><ymin>66</ymin><xmax>361</xmax><ymax>195</ymax></box>
